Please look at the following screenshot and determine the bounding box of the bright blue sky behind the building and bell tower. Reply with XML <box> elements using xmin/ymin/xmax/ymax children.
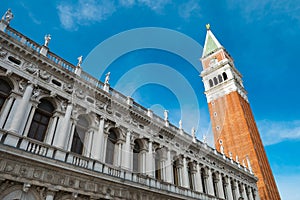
<box><xmin>0</xmin><ymin>0</ymin><xmax>300</xmax><ymax>200</ymax></box>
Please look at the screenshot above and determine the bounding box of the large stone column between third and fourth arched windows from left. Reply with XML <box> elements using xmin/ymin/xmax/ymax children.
<box><xmin>91</xmin><ymin>117</ymin><xmax>105</xmax><ymax>162</ymax></box>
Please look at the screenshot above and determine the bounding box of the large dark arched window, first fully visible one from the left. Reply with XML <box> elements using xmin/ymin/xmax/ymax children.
<box><xmin>27</xmin><ymin>99</ymin><xmax>54</xmax><ymax>142</ymax></box>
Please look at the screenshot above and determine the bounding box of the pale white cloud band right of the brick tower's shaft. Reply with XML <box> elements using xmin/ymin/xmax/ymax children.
<box><xmin>257</xmin><ymin>120</ymin><xmax>300</xmax><ymax>145</ymax></box>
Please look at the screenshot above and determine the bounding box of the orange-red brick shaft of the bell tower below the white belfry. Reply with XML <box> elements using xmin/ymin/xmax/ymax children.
<box><xmin>209</xmin><ymin>92</ymin><xmax>280</xmax><ymax>200</ymax></box>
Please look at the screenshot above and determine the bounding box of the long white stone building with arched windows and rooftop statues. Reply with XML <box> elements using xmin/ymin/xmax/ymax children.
<box><xmin>0</xmin><ymin>9</ymin><xmax>259</xmax><ymax>200</ymax></box>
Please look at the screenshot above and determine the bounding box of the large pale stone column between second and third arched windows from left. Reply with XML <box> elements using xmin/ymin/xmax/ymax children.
<box><xmin>54</xmin><ymin>104</ymin><xmax>73</xmax><ymax>149</ymax></box>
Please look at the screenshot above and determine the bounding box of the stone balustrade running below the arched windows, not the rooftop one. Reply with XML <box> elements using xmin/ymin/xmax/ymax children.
<box><xmin>0</xmin><ymin>130</ymin><xmax>219</xmax><ymax>200</ymax></box>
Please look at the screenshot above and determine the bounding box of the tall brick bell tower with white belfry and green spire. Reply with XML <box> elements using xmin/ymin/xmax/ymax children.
<box><xmin>201</xmin><ymin>25</ymin><xmax>280</xmax><ymax>200</ymax></box>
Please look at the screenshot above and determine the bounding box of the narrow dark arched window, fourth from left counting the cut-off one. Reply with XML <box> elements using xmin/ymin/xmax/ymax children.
<box><xmin>105</xmin><ymin>130</ymin><xmax>117</xmax><ymax>165</ymax></box>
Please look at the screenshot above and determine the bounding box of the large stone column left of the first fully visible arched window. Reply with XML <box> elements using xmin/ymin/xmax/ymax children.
<box><xmin>8</xmin><ymin>84</ymin><xmax>33</xmax><ymax>134</ymax></box>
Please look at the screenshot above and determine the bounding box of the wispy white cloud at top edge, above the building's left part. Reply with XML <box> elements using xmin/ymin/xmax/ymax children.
<box><xmin>57</xmin><ymin>0</ymin><xmax>116</xmax><ymax>30</ymax></box>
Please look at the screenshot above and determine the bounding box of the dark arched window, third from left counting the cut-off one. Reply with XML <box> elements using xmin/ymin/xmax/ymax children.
<box><xmin>71</xmin><ymin>116</ymin><xmax>89</xmax><ymax>154</ymax></box>
